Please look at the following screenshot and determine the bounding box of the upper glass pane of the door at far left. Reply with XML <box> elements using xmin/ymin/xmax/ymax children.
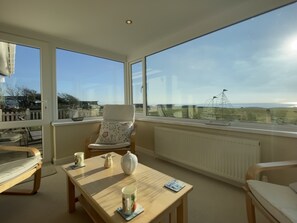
<box><xmin>0</xmin><ymin>42</ymin><xmax>42</xmax><ymax>122</ymax></box>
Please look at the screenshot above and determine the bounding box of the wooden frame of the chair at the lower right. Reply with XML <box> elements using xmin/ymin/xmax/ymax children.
<box><xmin>243</xmin><ymin>160</ymin><xmax>297</xmax><ymax>223</ymax></box>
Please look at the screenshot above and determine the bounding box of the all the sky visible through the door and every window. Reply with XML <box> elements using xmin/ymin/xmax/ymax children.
<box><xmin>2</xmin><ymin>3</ymin><xmax>297</xmax><ymax>106</ymax></box>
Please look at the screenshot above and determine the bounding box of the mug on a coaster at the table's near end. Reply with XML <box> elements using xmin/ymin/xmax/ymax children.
<box><xmin>122</xmin><ymin>185</ymin><xmax>137</xmax><ymax>215</ymax></box>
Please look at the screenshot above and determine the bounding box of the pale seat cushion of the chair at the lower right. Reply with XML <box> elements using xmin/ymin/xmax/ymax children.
<box><xmin>247</xmin><ymin>180</ymin><xmax>297</xmax><ymax>223</ymax></box>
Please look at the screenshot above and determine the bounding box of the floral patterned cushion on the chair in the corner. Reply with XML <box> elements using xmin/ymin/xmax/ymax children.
<box><xmin>95</xmin><ymin>121</ymin><xmax>133</xmax><ymax>144</ymax></box>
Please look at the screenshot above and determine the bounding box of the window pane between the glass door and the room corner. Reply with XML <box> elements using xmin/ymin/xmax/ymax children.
<box><xmin>56</xmin><ymin>49</ymin><xmax>124</xmax><ymax>119</ymax></box>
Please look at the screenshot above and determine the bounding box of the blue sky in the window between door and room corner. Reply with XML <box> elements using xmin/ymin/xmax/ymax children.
<box><xmin>56</xmin><ymin>49</ymin><xmax>124</xmax><ymax>104</ymax></box>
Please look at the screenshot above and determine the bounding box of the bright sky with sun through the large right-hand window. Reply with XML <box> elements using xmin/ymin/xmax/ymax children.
<box><xmin>146</xmin><ymin>3</ymin><xmax>297</xmax><ymax>105</ymax></box>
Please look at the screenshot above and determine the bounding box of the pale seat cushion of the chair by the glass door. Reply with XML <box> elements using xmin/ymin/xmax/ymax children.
<box><xmin>0</xmin><ymin>155</ymin><xmax>41</xmax><ymax>184</ymax></box>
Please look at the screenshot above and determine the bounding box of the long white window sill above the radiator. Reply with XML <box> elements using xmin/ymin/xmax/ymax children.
<box><xmin>136</xmin><ymin>116</ymin><xmax>297</xmax><ymax>138</ymax></box>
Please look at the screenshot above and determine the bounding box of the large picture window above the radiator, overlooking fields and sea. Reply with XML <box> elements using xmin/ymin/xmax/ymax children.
<box><xmin>146</xmin><ymin>3</ymin><xmax>297</xmax><ymax>128</ymax></box>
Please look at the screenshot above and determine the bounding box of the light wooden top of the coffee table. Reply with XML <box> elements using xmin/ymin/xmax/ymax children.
<box><xmin>62</xmin><ymin>153</ymin><xmax>193</xmax><ymax>222</ymax></box>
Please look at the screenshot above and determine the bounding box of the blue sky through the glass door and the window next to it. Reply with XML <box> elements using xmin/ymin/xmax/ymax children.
<box><xmin>1</xmin><ymin>45</ymin><xmax>124</xmax><ymax>104</ymax></box>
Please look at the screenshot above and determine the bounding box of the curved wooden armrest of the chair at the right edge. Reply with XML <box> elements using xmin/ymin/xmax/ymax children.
<box><xmin>245</xmin><ymin>160</ymin><xmax>297</xmax><ymax>180</ymax></box>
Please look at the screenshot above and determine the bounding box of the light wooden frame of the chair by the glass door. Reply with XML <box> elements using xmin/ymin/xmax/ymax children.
<box><xmin>0</xmin><ymin>146</ymin><xmax>42</xmax><ymax>195</ymax></box>
